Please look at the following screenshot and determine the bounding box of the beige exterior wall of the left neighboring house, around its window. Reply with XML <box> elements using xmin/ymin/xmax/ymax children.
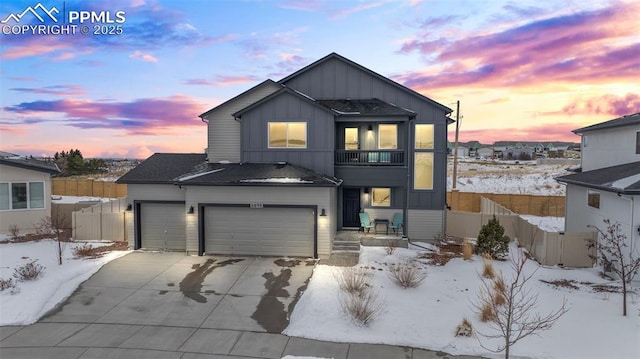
<box><xmin>0</xmin><ymin>165</ymin><xmax>51</xmax><ymax>234</ymax></box>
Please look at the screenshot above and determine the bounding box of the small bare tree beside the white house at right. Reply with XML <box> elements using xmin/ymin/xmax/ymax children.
<box><xmin>587</xmin><ymin>219</ymin><xmax>640</xmax><ymax>316</ymax></box>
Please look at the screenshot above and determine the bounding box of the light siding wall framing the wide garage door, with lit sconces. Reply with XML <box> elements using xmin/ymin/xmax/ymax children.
<box><xmin>186</xmin><ymin>186</ymin><xmax>336</xmax><ymax>258</ymax></box>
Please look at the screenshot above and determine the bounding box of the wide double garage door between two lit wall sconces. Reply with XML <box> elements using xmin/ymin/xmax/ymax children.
<box><xmin>204</xmin><ymin>207</ymin><xmax>314</xmax><ymax>257</ymax></box>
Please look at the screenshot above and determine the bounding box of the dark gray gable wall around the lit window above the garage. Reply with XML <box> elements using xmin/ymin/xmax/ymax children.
<box><xmin>241</xmin><ymin>92</ymin><xmax>335</xmax><ymax>176</ymax></box>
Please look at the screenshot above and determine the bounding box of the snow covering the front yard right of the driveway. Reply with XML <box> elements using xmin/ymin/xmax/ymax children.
<box><xmin>284</xmin><ymin>247</ymin><xmax>640</xmax><ymax>358</ymax></box>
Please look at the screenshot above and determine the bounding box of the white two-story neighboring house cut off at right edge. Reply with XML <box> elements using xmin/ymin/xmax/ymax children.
<box><xmin>557</xmin><ymin>113</ymin><xmax>640</xmax><ymax>264</ymax></box>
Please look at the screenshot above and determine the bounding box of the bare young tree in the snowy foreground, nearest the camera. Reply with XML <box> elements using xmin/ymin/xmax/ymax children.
<box><xmin>473</xmin><ymin>249</ymin><xmax>568</xmax><ymax>359</ymax></box>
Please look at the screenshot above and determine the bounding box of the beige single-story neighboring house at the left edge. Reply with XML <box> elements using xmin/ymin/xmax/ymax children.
<box><xmin>0</xmin><ymin>152</ymin><xmax>60</xmax><ymax>234</ymax></box>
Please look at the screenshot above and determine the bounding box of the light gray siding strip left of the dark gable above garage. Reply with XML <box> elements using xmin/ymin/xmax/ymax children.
<box><xmin>205</xmin><ymin>82</ymin><xmax>280</xmax><ymax>163</ymax></box>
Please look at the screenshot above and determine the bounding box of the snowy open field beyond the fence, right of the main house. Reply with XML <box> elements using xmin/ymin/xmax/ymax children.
<box><xmin>447</xmin><ymin>159</ymin><xmax>571</xmax><ymax>196</ymax></box>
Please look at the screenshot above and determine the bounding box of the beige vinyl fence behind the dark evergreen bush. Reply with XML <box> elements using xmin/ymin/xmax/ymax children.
<box><xmin>447</xmin><ymin>198</ymin><xmax>597</xmax><ymax>268</ymax></box>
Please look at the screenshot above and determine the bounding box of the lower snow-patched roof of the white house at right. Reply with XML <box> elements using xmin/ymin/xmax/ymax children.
<box><xmin>556</xmin><ymin>161</ymin><xmax>640</xmax><ymax>194</ymax></box>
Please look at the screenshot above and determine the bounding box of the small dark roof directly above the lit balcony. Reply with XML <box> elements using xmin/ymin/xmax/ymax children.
<box><xmin>316</xmin><ymin>98</ymin><xmax>416</xmax><ymax>117</ymax></box>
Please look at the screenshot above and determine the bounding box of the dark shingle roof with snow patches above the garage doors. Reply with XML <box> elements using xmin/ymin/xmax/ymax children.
<box><xmin>116</xmin><ymin>153</ymin><xmax>342</xmax><ymax>187</ymax></box>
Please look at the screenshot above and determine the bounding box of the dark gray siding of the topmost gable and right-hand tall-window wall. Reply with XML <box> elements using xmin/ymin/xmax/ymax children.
<box><xmin>285</xmin><ymin>58</ymin><xmax>447</xmax><ymax>210</ymax></box>
